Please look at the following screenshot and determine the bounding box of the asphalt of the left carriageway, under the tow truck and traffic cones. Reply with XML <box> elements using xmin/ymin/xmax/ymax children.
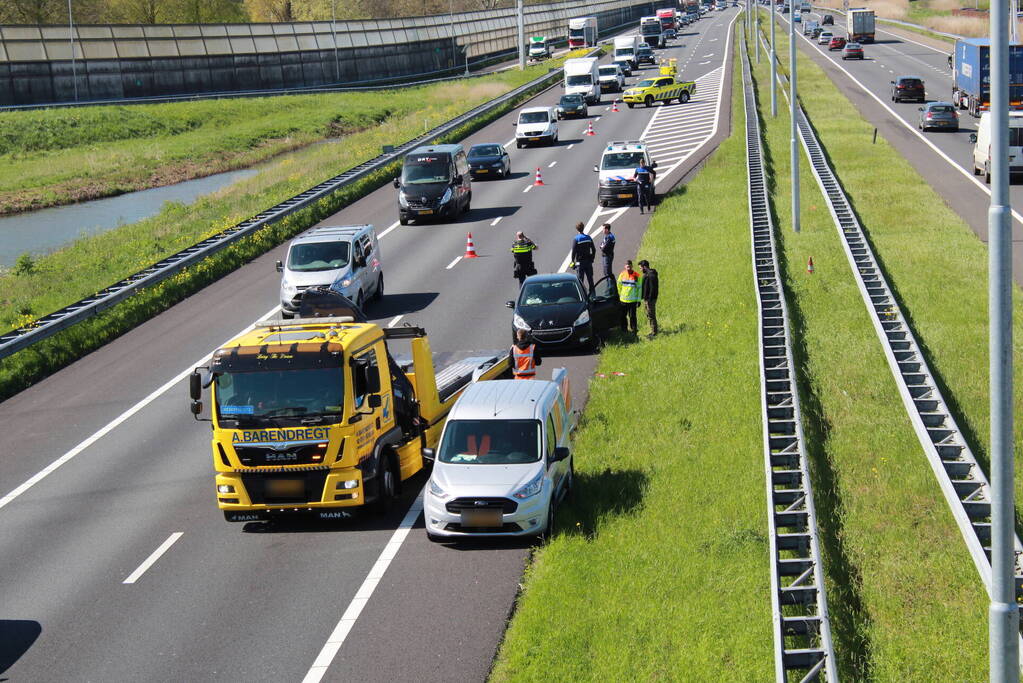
<box><xmin>0</xmin><ymin>9</ymin><xmax>739</xmax><ymax>681</ymax></box>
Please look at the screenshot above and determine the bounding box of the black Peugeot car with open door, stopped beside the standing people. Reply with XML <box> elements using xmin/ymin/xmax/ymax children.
<box><xmin>507</xmin><ymin>273</ymin><xmax>622</xmax><ymax>349</ymax></box>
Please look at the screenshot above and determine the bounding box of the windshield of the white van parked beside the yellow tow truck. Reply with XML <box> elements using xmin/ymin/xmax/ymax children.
<box><xmin>437</xmin><ymin>420</ymin><xmax>540</xmax><ymax>465</ymax></box>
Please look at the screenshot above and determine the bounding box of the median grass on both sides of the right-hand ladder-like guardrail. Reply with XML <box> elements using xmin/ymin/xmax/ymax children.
<box><xmin>755</xmin><ymin>26</ymin><xmax>987</xmax><ymax>681</ymax></box>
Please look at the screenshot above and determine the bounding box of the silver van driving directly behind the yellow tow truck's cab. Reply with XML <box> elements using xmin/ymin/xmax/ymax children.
<box><xmin>277</xmin><ymin>225</ymin><xmax>384</xmax><ymax>318</ymax></box>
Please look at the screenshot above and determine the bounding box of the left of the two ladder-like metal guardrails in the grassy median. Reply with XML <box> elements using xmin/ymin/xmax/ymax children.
<box><xmin>742</xmin><ymin>30</ymin><xmax>838</xmax><ymax>683</ymax></box>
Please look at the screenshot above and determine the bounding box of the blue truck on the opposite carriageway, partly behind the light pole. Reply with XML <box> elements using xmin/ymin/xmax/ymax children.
<box><xmin>949</xmin><ymin>38</ymin><xmax>1023</xmax><ymax>117</ymax></box>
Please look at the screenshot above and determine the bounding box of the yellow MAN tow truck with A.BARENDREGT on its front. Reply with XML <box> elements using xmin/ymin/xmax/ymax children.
<box><xmin>189</xmin><ymin>316</ymin><xmax>508</xmax><ymax>521</ymax></box>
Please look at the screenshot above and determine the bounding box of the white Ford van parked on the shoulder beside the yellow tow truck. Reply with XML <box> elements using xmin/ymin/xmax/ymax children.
<box><xmin>422</xmin><ymin>368</ymin><xmax>575</xmax><ymax>541</ymax></box>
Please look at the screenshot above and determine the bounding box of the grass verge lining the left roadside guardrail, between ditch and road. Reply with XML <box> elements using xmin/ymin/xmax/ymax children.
<box><xmin>0</xmin><ymin>54</ymin><xmax>597</xmax><ymax>400</ymax></box>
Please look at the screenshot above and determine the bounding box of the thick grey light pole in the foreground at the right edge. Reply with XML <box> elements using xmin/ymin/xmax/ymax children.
<box><xmin>987</xmin><ymin>0</ymin><xmax>1020</xmax><ymax>683</ymax></box>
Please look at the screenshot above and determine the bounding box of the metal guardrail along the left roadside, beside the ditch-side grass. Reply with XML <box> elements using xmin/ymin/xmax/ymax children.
<box><xmin>0</xmin><ymin>53</ymin><xmax>585</xmax><ymax>359</ymax></box>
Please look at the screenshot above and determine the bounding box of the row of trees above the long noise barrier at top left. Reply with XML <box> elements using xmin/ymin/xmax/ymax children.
<box><xmin>0</xmin><ymin>0</ymin><xmax>523</xmax><ymax>25</ymax></box>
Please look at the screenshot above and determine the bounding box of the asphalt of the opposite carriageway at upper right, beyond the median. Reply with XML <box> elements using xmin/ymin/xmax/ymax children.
<box><xmin>765</xmin><ymin>8</ymin><xmax>1023</xmax><ymax>284</ymax></box>
